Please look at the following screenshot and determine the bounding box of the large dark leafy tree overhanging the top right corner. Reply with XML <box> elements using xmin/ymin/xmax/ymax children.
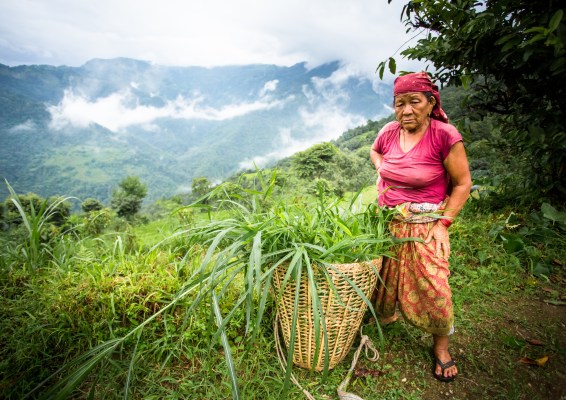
<box><xmin>384</xmin><ymin>0</ymin><xmax>566</xmax><ymax>199</ymax></box>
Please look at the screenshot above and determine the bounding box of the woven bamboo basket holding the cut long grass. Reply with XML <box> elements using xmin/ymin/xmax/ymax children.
<box><xmin>273</xmin><ymin>258</ymin><xmax>382</xmax><ymax>371</ymax></box>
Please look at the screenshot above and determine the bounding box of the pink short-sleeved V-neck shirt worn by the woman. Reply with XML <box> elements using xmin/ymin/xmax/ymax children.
<box><xmin>372</xmin><ymin>119</ymin><xmax>462</xmax><ymax>206</ymax></box>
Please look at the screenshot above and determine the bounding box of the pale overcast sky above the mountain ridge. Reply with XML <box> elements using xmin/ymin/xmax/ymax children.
<box><xmin>0</xmin><ymin>0</ymin><xmax>424</xmax><ymax>74</ymax></box>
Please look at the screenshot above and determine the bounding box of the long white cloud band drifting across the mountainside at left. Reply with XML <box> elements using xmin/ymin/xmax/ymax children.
<box><xmin>48</xmin><ymin>89</ymin><xmax>292</xmax><ymax>132</ymax></box>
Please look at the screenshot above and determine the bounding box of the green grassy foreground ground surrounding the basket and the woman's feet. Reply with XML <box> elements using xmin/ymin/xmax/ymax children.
<box><xmin>0</xmin><ymin>169</ymin><xmax>566</xmax><ymax>399</ymax></box>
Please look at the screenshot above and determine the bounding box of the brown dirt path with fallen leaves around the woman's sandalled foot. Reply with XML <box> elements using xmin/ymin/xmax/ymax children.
<box><xmin>378</xmin><ymin>289</ymin><xmax>566</xmax><ymax>400</ymax></box>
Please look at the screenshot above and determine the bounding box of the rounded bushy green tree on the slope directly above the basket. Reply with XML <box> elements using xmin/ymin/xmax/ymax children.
<box><xmin>293</xmin><ymin>142</ymin><xmax>338</xmax><ymax>179</ymax></box>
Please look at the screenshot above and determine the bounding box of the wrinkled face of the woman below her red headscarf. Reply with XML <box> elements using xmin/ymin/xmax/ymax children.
<box><xmin>394</xmin><ymin>92</ymin><xmax>436</xmax><ymax>133</ymax></box>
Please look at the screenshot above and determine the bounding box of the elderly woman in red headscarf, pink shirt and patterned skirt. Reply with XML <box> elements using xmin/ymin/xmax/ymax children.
<box><xmin>370</xmin><ymin>72</ymin><xmax>472</xmax><ymax>382</ymax></box>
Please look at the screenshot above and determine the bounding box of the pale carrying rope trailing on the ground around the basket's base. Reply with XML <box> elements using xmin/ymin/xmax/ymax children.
<box><xmin>273</xmin><ymin>313</ymin><xmax>379</xmax><ymax>400</ymax></box>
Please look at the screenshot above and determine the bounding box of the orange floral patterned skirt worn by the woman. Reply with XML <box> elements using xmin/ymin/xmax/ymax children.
<box><xmin>375</xmin><ymin>220</ymin><xmax>454</xmax><ymax>336</ymax></box>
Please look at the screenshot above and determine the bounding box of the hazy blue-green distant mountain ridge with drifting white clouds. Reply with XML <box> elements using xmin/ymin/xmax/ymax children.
<box><xmin>0</xmin><ymin>58</ymin><xmax>391</xmax><ymax>202</ymax></box>
